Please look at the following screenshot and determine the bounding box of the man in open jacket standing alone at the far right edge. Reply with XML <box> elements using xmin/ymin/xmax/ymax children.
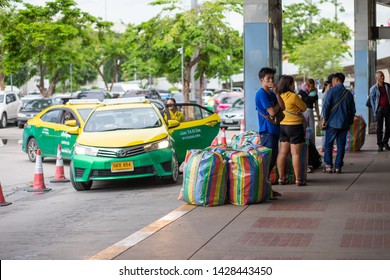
<box><xmin>370</xmin><ymin>71</ymin><xmax>390</xmax><ymax>152</ymax></box>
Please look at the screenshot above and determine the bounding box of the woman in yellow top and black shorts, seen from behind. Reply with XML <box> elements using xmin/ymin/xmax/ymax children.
<box><xmin>277</xmin><ymin>75</ymin><xmax>307</xmax><ymax>186</ymax></box>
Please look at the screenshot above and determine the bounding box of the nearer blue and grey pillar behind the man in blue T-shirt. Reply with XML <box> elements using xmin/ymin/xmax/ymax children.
<box><xmin>244</xmin><ymin>0</ymin><xmax>282</xmax><ymax>131</ymax></box>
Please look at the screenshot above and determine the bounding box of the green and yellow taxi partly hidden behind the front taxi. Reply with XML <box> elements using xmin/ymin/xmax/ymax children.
<box><xmin>22</xmin><ymin>100</ymin><xmax>100</xmax><ymax>162</ymax></box>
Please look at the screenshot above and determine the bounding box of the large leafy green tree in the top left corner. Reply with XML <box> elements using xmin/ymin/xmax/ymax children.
<box><xmin>2</xmin><ymin>0</ymin><xmax>97</xmax><ymax>96</ymax></box>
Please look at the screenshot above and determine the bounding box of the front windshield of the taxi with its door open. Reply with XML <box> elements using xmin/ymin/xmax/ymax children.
<box><xmin>84</xmin><ymin>108</ymin><xmax>162</xmax><ymax>132</ymax></box>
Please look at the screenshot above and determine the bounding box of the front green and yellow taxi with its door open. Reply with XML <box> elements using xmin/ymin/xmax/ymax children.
<box><xmin>70</xmin><ymin>99</ymin><xmax>220</xmax><ymax>191</ymax></box>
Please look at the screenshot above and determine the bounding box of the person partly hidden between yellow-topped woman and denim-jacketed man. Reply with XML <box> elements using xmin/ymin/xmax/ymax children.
<box><xmin>298</xmin><ymin>79</ymin><xmax>320</xmax><ymax>145</ymax></box>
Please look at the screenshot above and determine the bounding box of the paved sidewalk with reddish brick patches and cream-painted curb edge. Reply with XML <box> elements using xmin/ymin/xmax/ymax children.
<box><xmin>91</xmin><ymin>135</ymin><xmax>390</xmax><ymax>260</ymax></box>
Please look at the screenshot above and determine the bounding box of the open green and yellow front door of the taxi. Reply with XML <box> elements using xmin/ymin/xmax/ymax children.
<box><xmin>169</xmin><ymin>104</ymin><xmax>221</xmax><ymax>162</ymax></box>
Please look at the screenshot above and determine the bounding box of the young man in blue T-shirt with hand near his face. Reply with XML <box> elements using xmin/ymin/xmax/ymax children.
<box><xmin>255</xmin><ymin>67</ymin><xmax>285</xmax><ymax>196</ymax></box>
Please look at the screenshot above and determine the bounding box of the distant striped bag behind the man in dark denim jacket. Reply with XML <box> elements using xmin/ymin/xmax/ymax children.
<box><xmin>345</xmin><ymin>115</ymin><xmax>367</xmax><ymax>152</ymax></box>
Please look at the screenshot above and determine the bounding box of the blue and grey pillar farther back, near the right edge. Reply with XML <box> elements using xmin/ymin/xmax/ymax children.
<box><xmin>355</xmin><ymin>0</ymin><xmax>377</xmax><ymax>129</ymax></box>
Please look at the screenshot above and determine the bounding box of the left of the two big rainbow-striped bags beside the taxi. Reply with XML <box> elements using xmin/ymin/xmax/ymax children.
<box><xmin>179</xmin><ymin>150</ymin><xmax>227</xmax><ymax>206</ymax></box>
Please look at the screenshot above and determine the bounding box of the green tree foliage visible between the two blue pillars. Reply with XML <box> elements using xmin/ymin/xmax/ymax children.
<box><xmin>283</xmin><ymin>0</ymin><xmax>351</xmax><ymax>81</ymax></box>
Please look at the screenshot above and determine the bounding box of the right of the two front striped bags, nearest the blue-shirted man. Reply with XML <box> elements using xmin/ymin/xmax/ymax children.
<box><xmin>226</xmin><ymin>143</ymin><xmax>272</xmax><ymax>205</ymax></box>
